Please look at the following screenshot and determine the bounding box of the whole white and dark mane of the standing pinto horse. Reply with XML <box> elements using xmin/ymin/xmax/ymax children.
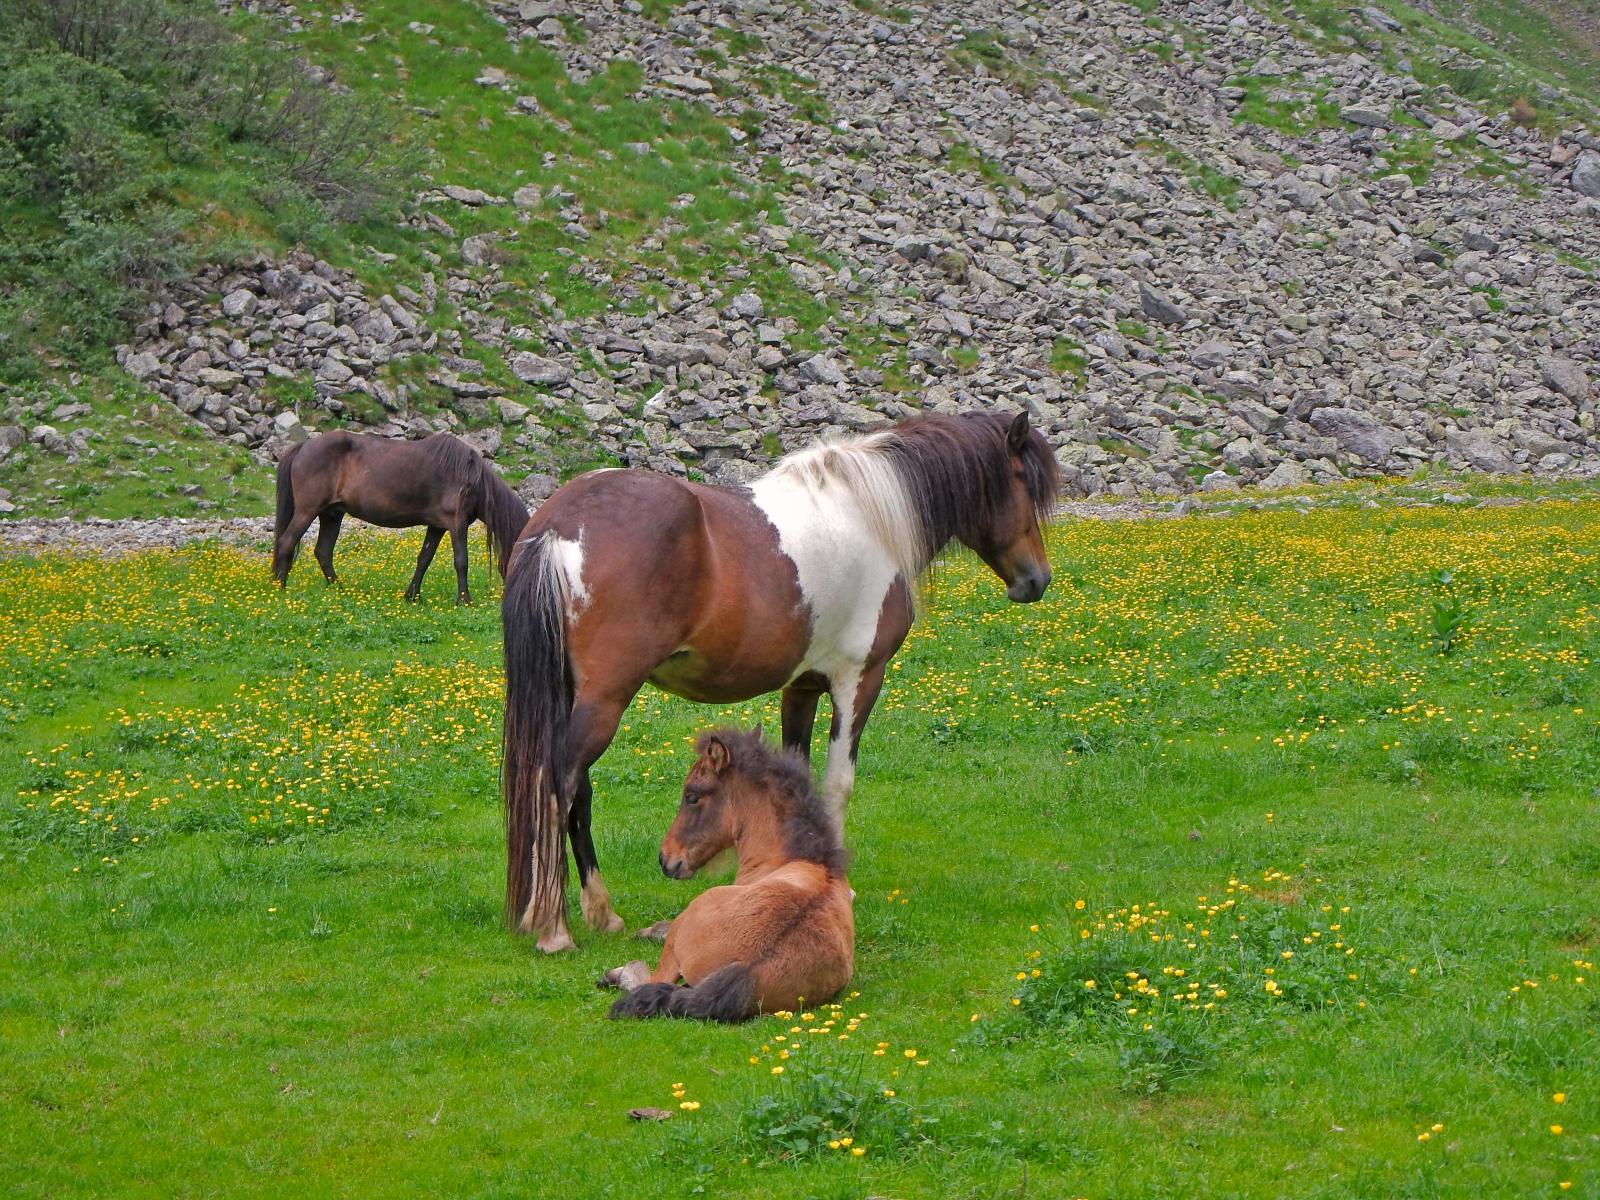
<box><xmin>771</xmin><ymin>413</ymin><xmax>1061</xmax><ymax>582</ymax></box>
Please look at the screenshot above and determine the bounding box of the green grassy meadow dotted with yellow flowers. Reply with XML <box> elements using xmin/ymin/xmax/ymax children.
<box><xmin>0</xmin><ymin>494</ymin><xmax>1600</xmax><ymax>1200</ymax></box>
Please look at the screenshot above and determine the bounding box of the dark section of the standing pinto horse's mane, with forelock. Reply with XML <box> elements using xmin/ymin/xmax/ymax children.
<box><xmin>874</xmin><ymin>413</ymin><xmax>1061</xmax><ymax>560</ymax></box>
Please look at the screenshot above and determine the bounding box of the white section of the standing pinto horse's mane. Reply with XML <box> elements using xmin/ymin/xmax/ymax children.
<box><xmin>768</xmin><ymin>430</ymin><xmax>928</xmax><ymax>592</ymax></box>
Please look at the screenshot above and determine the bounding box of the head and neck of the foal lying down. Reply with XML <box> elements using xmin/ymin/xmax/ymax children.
<box><xmin>661</xmin><ymin>730</ymin><xmax>845</xmax><ymax>878</ymax></box>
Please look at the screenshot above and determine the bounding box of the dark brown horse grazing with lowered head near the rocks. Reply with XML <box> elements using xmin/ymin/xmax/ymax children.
<box><xmin>272</xmin><ymin>429</ymin><xmax>528</xmax><ymax>605</ymax></box>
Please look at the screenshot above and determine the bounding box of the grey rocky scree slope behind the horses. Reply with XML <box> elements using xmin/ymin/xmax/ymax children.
<box><xmin>34</xmin><ymin>0</ymin><xmax>1600</xmax><ymax>494</ymax></box>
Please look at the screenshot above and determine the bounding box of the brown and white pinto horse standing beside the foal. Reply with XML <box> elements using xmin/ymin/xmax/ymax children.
<box><xmin>501</xmin><ymin>413</ymin><xmax>1059</xmax><ymax>950</ymax></box>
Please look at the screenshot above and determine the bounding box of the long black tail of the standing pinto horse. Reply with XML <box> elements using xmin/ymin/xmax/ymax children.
<box><xmin>501</xmin><ymin>534</ymin><xmax>573</xmax><ymax>936</ymax></box>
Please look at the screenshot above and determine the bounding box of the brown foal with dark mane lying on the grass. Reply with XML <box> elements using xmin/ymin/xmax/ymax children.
<box><xmin>600</xmin><ymin>730</ymin><xmax>856</xmax><ymax>1022</ymax></box>
